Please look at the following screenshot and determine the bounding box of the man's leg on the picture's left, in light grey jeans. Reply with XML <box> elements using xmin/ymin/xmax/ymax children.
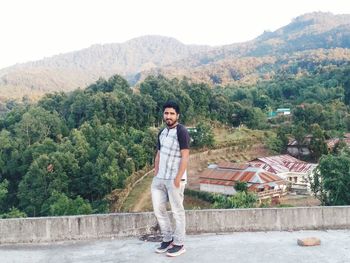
<box><xmin>151</xmin><ymin>177</ymin><xmax>172</xmax><ymax>242</ymax></box>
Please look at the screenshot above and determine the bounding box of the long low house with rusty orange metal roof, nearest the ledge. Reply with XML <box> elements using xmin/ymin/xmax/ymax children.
<box><xmin>200</xmin><ymin>162</ymin><xmax>287</xmax><ymax>198</ymax></box>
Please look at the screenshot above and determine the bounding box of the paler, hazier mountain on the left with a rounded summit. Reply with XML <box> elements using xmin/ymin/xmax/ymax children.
<box><xmin>0</xmin><ymin>36</ymin><xmax>211</xmax><ymax>100</ymax></box>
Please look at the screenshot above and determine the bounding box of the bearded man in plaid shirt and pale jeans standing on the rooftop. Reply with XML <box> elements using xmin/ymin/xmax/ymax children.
<box><xmin>151</xmin><ymin>101</ymin><xmax>190</xmax><ymax>257</ymax></box>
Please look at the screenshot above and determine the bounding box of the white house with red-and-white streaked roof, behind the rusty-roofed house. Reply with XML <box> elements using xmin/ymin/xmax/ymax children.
<box><xmin>249</xmin><ymin>154</ymin><xmax>317</xmax><ymax>193</ymax></box>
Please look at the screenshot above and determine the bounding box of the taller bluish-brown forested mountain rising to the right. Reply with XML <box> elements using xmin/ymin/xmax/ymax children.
<box><xmin>139</xmin><ymin>12</ymin><xmax>350</xmax><ymax>85</ymax></box>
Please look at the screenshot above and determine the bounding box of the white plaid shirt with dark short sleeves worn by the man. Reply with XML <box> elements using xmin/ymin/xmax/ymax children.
<box><xmin>157</xmin><ymin>124</ymin><xmax>190</xmax><ymax>180</ymax></box>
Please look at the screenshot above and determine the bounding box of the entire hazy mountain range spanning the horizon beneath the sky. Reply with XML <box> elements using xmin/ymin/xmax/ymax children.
<box><xmin>0</xmin><ymin>12</ymin><xmax>350</xmax><ymax>99</ymax></box>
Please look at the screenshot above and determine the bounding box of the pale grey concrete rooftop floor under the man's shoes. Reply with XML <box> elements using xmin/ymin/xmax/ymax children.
<box><xmin>0</xmin><ymin>230</ymin><xmax>350</xmax><ymax>263</ymax></box>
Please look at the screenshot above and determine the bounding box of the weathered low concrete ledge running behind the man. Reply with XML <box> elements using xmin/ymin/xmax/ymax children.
<box><xmin>0</xmin><ymin>206</ymin><xmax>350</xmax><ymax>244</ymax></box>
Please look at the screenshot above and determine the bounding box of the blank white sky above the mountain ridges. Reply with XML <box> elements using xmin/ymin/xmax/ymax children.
<box><xmin>0</xmin><ymin>0</ymin><xmax>350</xmax><ymax>69</ymax></box>
